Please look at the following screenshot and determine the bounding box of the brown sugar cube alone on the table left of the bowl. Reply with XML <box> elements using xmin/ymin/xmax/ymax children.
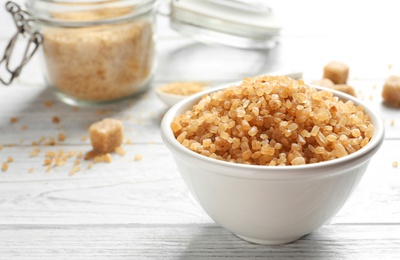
<box><xmin>89</xmin><ymin>118</ymin><xmax>124</xmax><ymax>153</ymax></box>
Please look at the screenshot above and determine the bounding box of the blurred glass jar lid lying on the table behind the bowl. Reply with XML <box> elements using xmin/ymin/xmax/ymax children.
<box><xmin>170</xmin><ymin>0</ymin><xmax>282</xmax><ymax>49</ymax></box>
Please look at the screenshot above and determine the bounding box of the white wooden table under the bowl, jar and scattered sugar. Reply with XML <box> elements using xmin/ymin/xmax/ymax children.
<box><xmin>0</xmin><ymin>0</ymin><xmax>400</xmax><ymax>259</ymax></box>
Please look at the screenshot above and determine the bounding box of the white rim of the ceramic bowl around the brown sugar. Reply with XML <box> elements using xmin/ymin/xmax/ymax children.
<box><xmin>161</xmin><ymin>81</ymin><xmax>385</xmax><ymax>178</ymax></box>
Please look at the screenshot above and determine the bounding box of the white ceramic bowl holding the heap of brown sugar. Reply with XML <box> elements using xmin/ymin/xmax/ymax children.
<box><xmin>161</xmin><ymin>83</ymin><xmax>384</xmax><ymax>244</ymax></box>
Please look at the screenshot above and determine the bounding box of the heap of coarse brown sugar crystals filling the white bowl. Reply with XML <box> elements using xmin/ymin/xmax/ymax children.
<box><xmin>171</xmin><ymin>76</ymin><xmax>374</xmax><ymax>166</ymax></box>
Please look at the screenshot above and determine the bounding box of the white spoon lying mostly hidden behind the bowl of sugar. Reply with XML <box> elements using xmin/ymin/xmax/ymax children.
<box><xmin>155</xmin><ymin>71</ymin><xmax>303</xmax><ymax>107</ymax></box>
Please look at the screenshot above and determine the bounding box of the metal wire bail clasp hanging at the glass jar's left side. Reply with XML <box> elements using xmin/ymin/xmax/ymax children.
<box><xmin>0</xmin><ymin>1</ymin><xmax>43</xmax><ymax>86</ymax></box>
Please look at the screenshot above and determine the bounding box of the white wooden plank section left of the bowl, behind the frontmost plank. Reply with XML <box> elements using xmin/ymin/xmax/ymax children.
<box><xmin>0</xmin><ymin>144</ymin><xmax>210</xmax><ymax>223</ymax></box>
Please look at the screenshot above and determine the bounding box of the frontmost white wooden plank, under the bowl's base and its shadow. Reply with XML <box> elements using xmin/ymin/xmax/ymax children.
<box><xmin>0</xmin><ymin>224</ymin><xmax>400</xmax><ymax>259</ymax></box>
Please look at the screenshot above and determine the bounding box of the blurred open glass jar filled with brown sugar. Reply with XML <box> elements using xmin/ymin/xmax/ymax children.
<box><xmin>4</xmin><ymin>0</ymin><xmax>157</xmax><ymax>105</ymax></box>
